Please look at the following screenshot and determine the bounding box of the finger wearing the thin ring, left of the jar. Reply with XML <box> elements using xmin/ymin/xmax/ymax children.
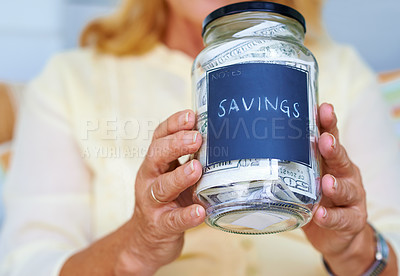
<box><xmin>150</xmin><ymin>160</ymin><xmax>201</xmax><ymax>204</ymax></box>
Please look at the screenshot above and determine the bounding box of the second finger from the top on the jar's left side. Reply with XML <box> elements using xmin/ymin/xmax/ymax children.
<box><xmin>143</xmin><ymin>131</ymin><xmax>202</xmax><ymax>175</ymax></box>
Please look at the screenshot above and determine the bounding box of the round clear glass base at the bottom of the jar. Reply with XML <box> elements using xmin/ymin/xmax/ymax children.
<box><xmin>206</xmin><ymin>200</ymin><xmax>312</xmax><ymax>235</ymax></box>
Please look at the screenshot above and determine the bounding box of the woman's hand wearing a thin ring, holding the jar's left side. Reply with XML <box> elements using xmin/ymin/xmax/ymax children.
<box><xmin>116</xmin><ymin>110</ymin><xmax>205</xmax><ymax>275</ymax></box>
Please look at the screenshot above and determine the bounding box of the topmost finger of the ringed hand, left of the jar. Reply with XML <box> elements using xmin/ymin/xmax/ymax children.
<box><xmin>153</xmin><ymin>109</ymin><xmax>195</xmax><ymax>140</ymax></box>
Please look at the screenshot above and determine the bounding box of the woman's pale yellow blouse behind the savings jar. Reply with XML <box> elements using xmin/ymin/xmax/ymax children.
<box><xmin>0</xmin><ymin>44</ymin><xmax>400</xmax><ymax>276</ymax></box>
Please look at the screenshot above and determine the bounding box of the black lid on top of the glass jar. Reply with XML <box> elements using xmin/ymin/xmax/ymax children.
<box><xmin>203</xmin><ymin>1</ymin><xmax>306</xmax><ymax>34</ymax></box>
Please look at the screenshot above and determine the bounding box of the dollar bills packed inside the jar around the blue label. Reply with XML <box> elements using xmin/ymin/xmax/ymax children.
<box><xmin>195</xmin><ymin>30</ymin><xmax>318</xmax><ymax>203</ymax></box>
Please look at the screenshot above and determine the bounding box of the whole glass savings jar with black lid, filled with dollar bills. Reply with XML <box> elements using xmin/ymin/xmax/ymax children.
<box><xmin>192</xmin><ymin>1</ymin><xmax>320</xmax><ymax>234</ymax></box>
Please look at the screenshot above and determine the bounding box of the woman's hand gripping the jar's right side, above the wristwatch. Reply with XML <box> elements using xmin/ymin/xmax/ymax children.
<box><xmin>303</xmin><ymin>104</ymin><xmax>375</xmax><ymax>275</ymax></box>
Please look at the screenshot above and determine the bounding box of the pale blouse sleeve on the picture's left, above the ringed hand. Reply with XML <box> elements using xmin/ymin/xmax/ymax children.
<box><xmin>0</xmin><ymin>56</ymin><xmax>91</xmax><ymax>276</ymax></box>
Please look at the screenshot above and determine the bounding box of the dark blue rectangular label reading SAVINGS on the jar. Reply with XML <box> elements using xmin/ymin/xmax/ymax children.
<box><xmin>207</xmin><ymin>63</ymin><xmax>310</xmax><ymax>166</ymax></box>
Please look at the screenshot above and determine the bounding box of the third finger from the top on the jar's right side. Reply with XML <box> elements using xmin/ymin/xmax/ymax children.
<box><xmin>321</xmin><ymin>174</ymin><xmax>365</xmax><ymax>207</ymax></box>
